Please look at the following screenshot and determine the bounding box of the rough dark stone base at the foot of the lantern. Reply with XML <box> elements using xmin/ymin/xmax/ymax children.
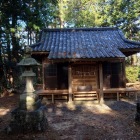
<box><xmin>6</xmin><ymin>107</ymin><xmax>48</xmax><ymax>134</ymax></box>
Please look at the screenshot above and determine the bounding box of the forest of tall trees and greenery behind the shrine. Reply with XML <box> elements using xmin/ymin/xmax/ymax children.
<box><xmin>0</xmin><ymin>0</ymin><xmax>140</xmax><ymax>91</ymax></box>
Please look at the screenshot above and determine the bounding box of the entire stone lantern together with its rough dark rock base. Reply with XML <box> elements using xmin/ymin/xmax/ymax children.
<box><xmin>6</xmin><ymin>47</ymin><xmax>47</xmax><ymax>133</ymax></box>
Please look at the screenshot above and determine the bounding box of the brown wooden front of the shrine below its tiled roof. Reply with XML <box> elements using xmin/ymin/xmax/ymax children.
<box><xmin>37</xmin><ymin>59</ymin><xmax>135</xmax><ymax>102</ymax></box>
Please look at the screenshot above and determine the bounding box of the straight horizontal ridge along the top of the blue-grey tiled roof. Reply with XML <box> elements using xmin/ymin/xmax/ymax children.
<box><xmin>42</xmin><ymin>27</ymin><xmax>118</xmax><ymax>32</ymax></box>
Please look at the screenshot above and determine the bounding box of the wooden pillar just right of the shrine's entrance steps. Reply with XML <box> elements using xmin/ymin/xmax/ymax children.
<box><xmin>99</xmin><ymin>63</ymin><xmax>104</xmax><ymax>103</ymax></box>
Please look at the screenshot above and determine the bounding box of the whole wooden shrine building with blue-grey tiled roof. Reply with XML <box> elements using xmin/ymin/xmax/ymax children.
<box><xmin>30</xmin><ymin>28</ymin><xmax>140</xmax><ymax>100</ymax></box>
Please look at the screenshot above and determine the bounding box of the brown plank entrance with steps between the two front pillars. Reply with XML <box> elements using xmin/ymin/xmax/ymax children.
<box><xmin>72</xmin><ymin>64</ymin><xmax>99</xmax><ymax>101</ymax></box>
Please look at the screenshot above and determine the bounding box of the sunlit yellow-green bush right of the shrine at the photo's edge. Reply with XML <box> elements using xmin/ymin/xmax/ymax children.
<box><xmin>126</xmin><ymin>66</ymin><xmax>140</xmax><ymax>82</ymax></box>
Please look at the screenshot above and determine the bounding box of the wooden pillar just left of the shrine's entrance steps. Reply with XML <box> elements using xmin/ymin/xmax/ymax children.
<box><xmin>68</xmin><ymin>65</ymin><xmax>72</xmax><ymax>102</ymax></box>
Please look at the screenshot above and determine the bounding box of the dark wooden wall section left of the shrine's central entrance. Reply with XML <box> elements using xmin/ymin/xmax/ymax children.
<box><xmin>44</xmin><ymin>63</ymin><xmax>68</xmax><ymax>89</ymax></box>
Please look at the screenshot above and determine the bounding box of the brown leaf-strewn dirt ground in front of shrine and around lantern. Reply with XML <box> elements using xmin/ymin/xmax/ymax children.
<box><xmin>0</xmin><ymin>94</ymin><xmax>140</xmax><ymax>140</ymax></box>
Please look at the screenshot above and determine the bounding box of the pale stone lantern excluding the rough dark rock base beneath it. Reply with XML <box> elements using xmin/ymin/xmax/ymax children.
<box><xmin>18</xmin><ymin>47</ymin><xmax>40</xmax><ymax>111</ymax></box>
